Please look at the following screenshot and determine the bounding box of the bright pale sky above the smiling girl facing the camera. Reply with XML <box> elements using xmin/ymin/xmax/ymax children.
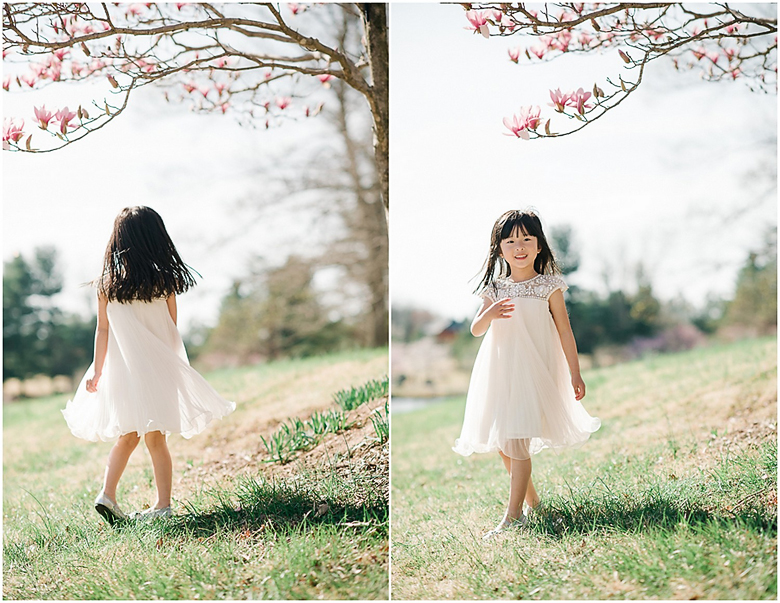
<box><xmin>390</xmin><ymin>4</ymin><xmax>777</xmax><ymax>318</ymax></box>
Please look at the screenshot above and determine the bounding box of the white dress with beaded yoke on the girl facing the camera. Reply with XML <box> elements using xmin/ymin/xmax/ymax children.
<box><xmin>453</xmin><ymin>274</ymin><xmax>601</xmax><ymax>460</ymax></box>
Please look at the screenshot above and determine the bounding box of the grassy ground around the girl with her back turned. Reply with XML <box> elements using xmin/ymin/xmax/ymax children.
<box><xmin>3</xmin><ymin>350</ymin><xmax>389</xmax><ymax>599</ymax></box>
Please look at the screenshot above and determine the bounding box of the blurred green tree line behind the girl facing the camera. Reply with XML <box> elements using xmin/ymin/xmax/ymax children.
<box><xmin>400</xmin><ymin>227</ymin><xmax>777</xmax><ymax>367</ymax></box>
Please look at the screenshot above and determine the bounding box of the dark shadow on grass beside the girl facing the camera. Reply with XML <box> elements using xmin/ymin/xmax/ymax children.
<box><xmin>530</xmin><ymin>486</ymin><xmax>777</xmax><ymax>537</ymax></box>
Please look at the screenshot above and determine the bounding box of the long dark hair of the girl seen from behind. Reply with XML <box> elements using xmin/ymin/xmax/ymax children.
<box><xmin>92</xmin><ymin>206</ymin><xmax>195</xmax><ymax>303</ymax></box>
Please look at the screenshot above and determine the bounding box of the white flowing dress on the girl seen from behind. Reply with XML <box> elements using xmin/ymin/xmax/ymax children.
<box><xmin>62</xmin><ymin>299</ymin><xmax>236</xmax><ymax>442</ymax></box>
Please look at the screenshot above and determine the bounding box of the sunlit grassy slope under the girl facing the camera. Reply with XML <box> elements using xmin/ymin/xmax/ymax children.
<box><xmin>391</xmin><ymin>339</ymin><xmax>777</xmax><ymax>599</ymax></box>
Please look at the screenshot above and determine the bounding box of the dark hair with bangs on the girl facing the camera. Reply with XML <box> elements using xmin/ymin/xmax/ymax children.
<box><xmin>476</xmin><ymin>209</ymin><xmax>560</xmax><ymax>293</ymax></box>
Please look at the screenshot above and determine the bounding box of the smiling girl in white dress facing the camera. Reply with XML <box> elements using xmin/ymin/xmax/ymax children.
<box><xmin>453</xmin><ymin>211</ymin><xmax>601</xmax><ymax>538</ymax></box>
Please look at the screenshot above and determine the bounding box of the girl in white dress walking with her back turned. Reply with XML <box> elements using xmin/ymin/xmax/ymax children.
<box><xmin>62</xmin><ymin>207</ymin><xmax>236</xmax><ymax>525</ymax></box>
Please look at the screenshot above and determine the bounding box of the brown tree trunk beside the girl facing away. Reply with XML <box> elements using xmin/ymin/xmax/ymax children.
<box><xmin>360</xmin><ymin>3</ymin><xmax>390</xmax><ymax>218</ymax></box>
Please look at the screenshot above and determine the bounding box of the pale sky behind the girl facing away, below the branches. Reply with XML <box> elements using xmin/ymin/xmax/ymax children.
<box><xmin>1</xmin><ymin>49</ymin><xmax>338</xmax><ymax>331</ymax></box>
